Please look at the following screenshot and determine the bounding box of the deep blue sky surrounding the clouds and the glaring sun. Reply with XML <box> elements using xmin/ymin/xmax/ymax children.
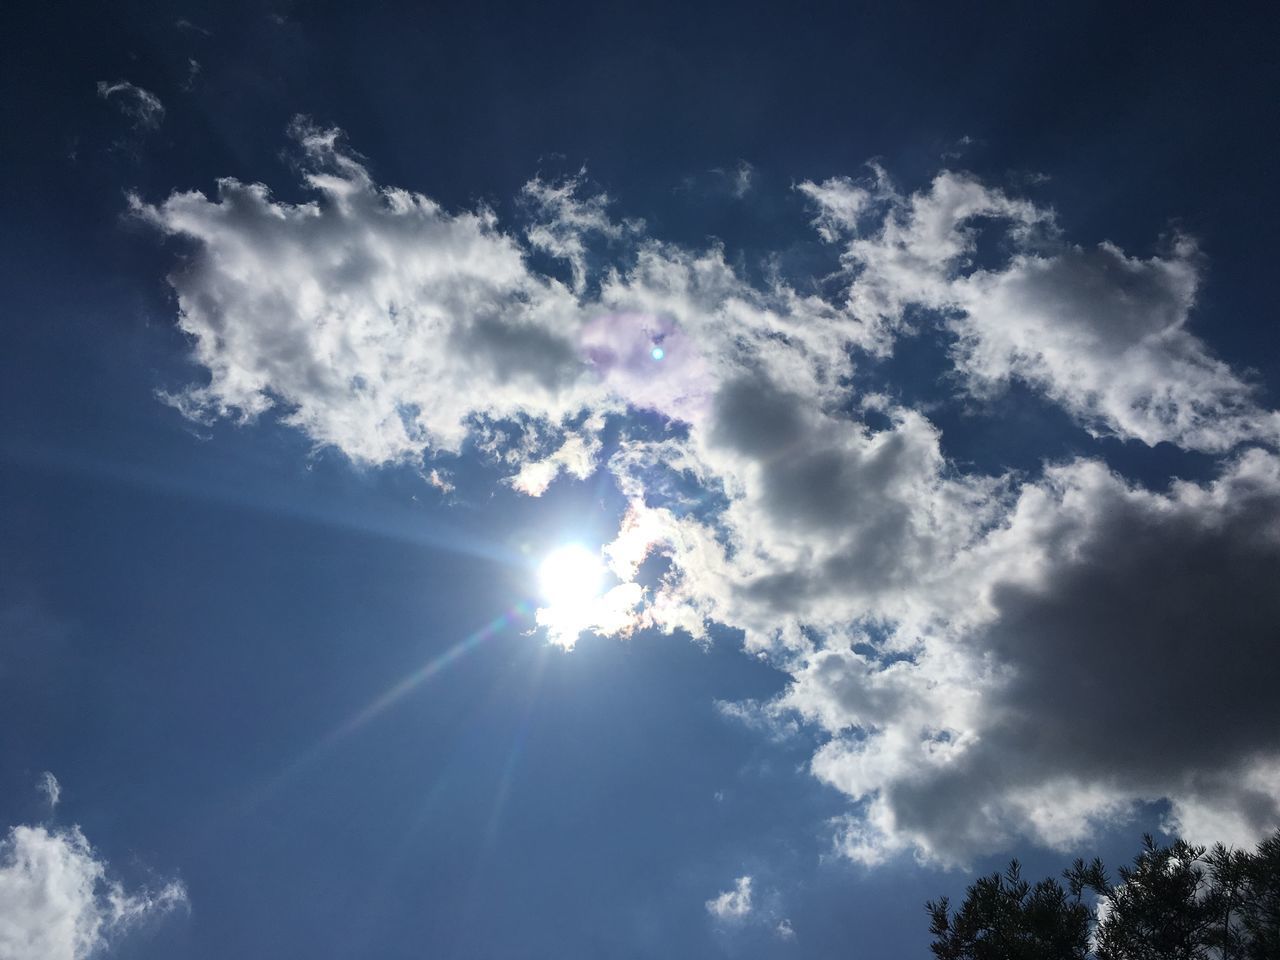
<box><xmin>0</xmin><ymin>3</ymin><xmax>1280</xmax><ymax>960</ymax></box>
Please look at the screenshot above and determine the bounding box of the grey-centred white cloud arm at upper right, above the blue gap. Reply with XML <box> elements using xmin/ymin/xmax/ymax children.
<box><xmin>800</xmin><ymin>173</ymin><xmax>1280</xmax><ymax>453</ymax></box>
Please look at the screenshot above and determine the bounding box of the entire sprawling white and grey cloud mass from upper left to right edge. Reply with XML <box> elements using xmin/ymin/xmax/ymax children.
<box><xmin>133</xmin><ymin>119</ymin><xmax>1280</xmax><ymax>863</ymax></box>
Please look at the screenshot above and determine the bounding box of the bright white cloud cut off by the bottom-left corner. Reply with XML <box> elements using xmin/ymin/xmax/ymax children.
<box><xmin>0</xmin><ymin>826</ymin><xmax>187</xmax><ymax>960</ymax></box>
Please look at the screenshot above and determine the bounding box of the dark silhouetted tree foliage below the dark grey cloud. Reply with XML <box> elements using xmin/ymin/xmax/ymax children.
<box><xmin>925</xmin><ymin>832</ymin><xmax>1280</xmax><ymax>960</ymax></box>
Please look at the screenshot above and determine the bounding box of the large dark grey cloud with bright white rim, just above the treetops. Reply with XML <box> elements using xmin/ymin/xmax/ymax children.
<box><xmin>803</xmin><ymin>451</ymin><xmax>1280</xmax><ymax>863</ymax></box>
